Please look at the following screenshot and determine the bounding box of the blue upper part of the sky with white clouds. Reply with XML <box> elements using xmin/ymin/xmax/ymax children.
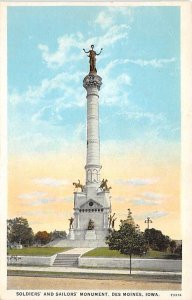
<box><xmin>8</xmin><ymin>7</ymin><xmax>180</xmax><ymax>154</ymax></box>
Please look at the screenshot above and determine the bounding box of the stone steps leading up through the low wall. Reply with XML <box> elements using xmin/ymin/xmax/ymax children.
<box><xmin>53</xmin><ymin>254</ymin><xmax>80</xmax><ymax>267</ymax></box>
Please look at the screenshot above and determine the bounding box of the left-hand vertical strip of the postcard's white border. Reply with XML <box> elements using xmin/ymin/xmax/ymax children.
<box><xmin>0</xmin><ymin>3</ymin><xmax>8</xmax><ymax>299</ymax></box>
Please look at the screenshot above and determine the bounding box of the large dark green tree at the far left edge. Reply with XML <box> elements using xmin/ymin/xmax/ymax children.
<box><xmin>7</xmin><ymin>217</ymin><xmax>34</xmax><ymax>245</ymax></box>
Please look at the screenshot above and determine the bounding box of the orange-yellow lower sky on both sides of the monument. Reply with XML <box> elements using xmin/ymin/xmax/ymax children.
<box><xmin>8</xmin><ymin>144</ymin><xmax>181</xmax><ymax>239</ymax></box>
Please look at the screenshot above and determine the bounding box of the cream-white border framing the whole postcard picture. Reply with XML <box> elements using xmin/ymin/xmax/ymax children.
<box><xmin>0</xmin><ymin>1</ymin><xmax>192</xmax><ymax>300</ymax></box>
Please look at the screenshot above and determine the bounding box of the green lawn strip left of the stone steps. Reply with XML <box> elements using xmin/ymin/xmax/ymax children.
<box><xmin>7</xmin><ymin>247</ymin><xmax>71</xmax><ymax>256</ymax></box>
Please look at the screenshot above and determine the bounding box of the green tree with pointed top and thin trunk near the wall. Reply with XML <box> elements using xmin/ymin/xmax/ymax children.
<box><xmin>107</xmin><ymin>209</ymin><xmax>147</xmax><ymax>274</ymax></box>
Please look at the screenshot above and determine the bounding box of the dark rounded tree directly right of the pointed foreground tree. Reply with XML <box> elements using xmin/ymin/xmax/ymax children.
<box><xmin>144</xmin><ymin>228</ymin><xmax>170</xmax><ymax>251</ymax></box>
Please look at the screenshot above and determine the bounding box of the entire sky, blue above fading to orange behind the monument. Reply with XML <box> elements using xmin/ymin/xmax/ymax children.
<box><xmin>8</xmin><ymin>6</ymin><xmax>181</xmax><ymax>239</ymax></box>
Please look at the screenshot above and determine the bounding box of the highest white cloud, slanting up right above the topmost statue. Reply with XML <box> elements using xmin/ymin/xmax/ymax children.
<box><xmin>38</xmin><ymin>7</ymin><xmax>134</xmax><ymax>69</ymax></box>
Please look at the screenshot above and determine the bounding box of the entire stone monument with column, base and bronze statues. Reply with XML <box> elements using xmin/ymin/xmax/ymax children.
<box><xmin>57</xmin><ymin>45</ymin><xmax>116</xmax><ymax>247</ymax></box>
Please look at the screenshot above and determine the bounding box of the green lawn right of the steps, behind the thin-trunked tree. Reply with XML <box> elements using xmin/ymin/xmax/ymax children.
<box><xmin>83</xmin><ymin>247</ymin><xmax>182</xmax><ymax>259</ymax></box>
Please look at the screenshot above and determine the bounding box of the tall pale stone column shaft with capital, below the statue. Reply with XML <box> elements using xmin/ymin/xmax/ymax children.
<box><xmin>83</xmin><ymin>73</ymin><xmax>102</xmax><ymax>189</ymax></box>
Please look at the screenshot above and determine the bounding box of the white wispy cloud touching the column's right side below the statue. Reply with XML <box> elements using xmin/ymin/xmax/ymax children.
<box><xmin>97</xmin><ymin>58</ymin><xmax>175</xmax><ymax>110</ymax></box>
